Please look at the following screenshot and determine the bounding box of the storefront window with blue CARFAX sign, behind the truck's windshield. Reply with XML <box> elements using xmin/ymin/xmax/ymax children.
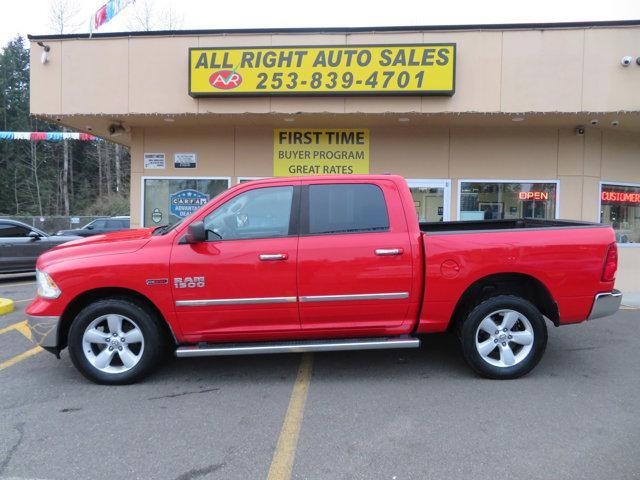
<box><xmin>143</xmin><ymin>178</ymin><xmax>229</xmax><ymax>227</ymax></box>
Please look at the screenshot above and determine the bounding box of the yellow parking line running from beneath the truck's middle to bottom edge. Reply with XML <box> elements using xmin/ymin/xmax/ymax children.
<box><xmin>267</xmin><ymin>353</ymin><xmax>313</xmax><ymax>480</ymax></box>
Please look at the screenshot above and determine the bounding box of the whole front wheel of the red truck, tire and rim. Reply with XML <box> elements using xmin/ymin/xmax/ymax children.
<box><xmin>68</xmin><ymin>298</ymin><xmax>162</xmax><ymax>385</ymax></box>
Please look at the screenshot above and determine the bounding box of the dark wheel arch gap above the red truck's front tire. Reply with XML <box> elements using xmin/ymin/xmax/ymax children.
<box><xmin>58</xmin><ymin>287</ymin><xmax>178</xmax><ymax>350</ymax></box>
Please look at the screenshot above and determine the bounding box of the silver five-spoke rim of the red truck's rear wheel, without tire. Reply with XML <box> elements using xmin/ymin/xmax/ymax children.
<box><xmin>476</xmin><ymin>310</ymin><xmax>533</xmax><ymax>368</ymax></box>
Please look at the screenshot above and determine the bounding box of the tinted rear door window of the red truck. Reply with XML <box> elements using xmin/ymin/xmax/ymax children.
<box><xmin>306</xmin><ymin>183</ymin><xmax>389</xmax><ymax>235</ymax></box>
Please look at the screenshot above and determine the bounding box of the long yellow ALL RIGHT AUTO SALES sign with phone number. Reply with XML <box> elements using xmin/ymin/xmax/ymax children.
<box><xmin>189</xmin><ymin>43</ymin><xmax>456</xmax><ymax>97</ymax></box>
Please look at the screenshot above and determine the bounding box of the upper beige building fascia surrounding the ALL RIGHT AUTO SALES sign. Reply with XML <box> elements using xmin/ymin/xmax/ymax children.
<box><xmin>31</xmin><ymin>27</ymin><xmax>640</xmax><ymax>115</ymax></box>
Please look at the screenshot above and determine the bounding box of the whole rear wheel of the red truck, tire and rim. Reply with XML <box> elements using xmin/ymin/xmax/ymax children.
<box><xmin>461</xmin><ymin>295</ymin><xmax>547</xmax><ymax>379</ymax></box>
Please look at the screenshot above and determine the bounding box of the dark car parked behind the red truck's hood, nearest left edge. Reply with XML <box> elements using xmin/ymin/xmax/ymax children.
<box><xmin>0</xmin><ymin>218</ymin><xmax>80</xmax><ymax>273</ymax></box>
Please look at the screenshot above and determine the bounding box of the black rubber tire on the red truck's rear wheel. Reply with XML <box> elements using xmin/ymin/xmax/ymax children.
<box><xmin>460</xmin><ymin>295</ymin><xmax>547</xmax><ymax>380</ymax></box>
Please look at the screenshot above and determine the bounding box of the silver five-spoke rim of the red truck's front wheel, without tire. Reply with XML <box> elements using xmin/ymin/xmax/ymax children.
<box><xmin>82</xmin><ymin>313</ymin><xmax>144</xmax><ymax>373</ymax></box>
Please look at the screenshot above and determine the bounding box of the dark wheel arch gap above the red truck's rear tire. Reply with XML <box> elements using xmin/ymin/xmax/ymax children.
<box><xmin>449</xmin><ymin>272</ymin><xmax>560</xmax><ymax>328</ymax></box>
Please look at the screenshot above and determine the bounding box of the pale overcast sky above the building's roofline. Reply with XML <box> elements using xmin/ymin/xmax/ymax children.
<box><xmin>0</xmin><ymin>0</ymin><xmax>640</xmax><ymax>46</ymax></box>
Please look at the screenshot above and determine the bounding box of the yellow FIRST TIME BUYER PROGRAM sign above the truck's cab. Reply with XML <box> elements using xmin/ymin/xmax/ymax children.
<box><xmin>273</xmin><ymin>128</ymin><xmax>369</xmax><ymax>177</ymax></box>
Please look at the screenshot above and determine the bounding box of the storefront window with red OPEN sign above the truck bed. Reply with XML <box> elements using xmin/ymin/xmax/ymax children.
<box><xmin>460</xmin><ymin>182</ymin><xmax>557</xmax><ymax>220</ymax></box>
